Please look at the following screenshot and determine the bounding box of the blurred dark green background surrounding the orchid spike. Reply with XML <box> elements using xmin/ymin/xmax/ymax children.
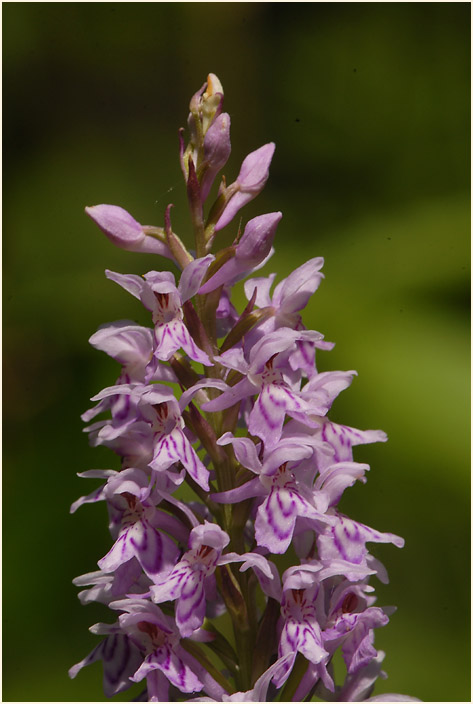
<box><xmin>2</xmin><ymin>3</ymin><xmax>470</xmax><ymax>701</ymax></box>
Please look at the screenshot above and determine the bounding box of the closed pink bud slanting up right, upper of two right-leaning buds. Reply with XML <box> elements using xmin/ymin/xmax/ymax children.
<box><xmin>215</xmin><ymin>142</ymin><xmax>275</xmax><ymax>232</ymax></box>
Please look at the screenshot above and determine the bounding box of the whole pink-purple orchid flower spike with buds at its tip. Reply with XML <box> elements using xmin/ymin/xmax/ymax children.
<box><xmin>70</xmin><ymin>74</ymin><xmax>417</xmax><ymax>701</ymax></box>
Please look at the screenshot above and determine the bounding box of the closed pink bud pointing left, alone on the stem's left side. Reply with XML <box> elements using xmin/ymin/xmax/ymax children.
<box><xmin>85</xmin><ymin>205</ymin><xmax>172</xmax><ymax>259</ymax></box>
